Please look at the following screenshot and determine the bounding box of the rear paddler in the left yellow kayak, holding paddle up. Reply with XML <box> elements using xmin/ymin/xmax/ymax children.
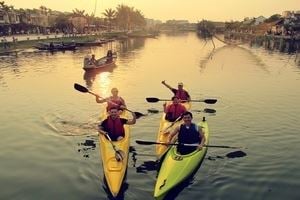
<box><xmin>96</xmin><ymin>88</ymin><xmax>126</xmax><ymax>111</ymax></box>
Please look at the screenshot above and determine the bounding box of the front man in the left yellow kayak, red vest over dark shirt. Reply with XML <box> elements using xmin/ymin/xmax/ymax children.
<box><xmin>98</xmin><ymin>107</ymin><xmax>136</xmax><ymax>141</ymax></box>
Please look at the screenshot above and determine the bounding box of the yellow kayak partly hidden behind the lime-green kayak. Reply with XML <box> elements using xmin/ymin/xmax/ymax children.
<box><xmin>156</xmin><ymin>101</ymin><xmax>192</xmax><ymax>159</ymax></box>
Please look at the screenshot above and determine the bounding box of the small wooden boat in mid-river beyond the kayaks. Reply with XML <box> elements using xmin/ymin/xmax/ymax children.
<box><xmin>83</xmin><ymin>53</ymin><xmax>117</xmax><ymax>70</ymax></box>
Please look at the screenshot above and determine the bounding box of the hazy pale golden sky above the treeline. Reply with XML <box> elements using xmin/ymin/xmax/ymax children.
<box><xmin>4</xmin><ymin>0</ymin><xmax>300</xmax><ymax>22</ymax></box>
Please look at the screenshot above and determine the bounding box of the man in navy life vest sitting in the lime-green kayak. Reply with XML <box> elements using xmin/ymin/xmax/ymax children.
<box><xmin>169</xmin><ymin>111</ymin><xmax>205</xmax><ymax>155</ymax></box>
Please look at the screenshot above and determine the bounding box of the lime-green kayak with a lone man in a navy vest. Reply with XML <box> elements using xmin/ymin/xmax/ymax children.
<box><xmin>154</xmin><ymin>118</ymin><xmax>209</xmax><ymax>199</ymax></box>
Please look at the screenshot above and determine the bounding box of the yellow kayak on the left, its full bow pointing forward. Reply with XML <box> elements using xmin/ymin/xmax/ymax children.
<box><xmin>99</xmin><ymin>111</ymin><xmax>130</xmax><ymax>197</ymax></box>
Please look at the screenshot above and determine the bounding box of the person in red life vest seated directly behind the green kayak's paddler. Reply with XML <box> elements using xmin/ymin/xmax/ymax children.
<box><xmin>163</xmin><ymin>96</ymin><xmax>186</xmax><ymax>122</ymax></box>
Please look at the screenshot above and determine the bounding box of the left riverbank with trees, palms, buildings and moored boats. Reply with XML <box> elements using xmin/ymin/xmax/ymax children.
<box><xmin>0</xmin><ymin>1</ymin><xmax>158</xmax><ymax>54</ymax></box>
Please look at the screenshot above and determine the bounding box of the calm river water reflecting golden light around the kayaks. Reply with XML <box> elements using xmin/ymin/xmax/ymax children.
<box><xmin>0</xmin><ymin>33</ymin><xmax>300</xmax><ymax>200</ymax></box>
